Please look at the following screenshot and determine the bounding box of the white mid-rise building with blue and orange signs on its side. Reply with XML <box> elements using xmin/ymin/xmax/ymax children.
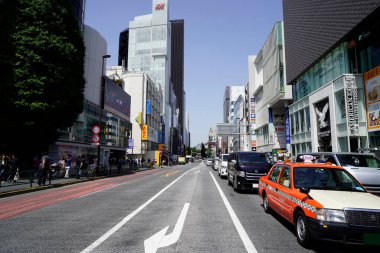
<box><xmin>107</xmin><ymin>66</ymin><xmax>163</xmax><ymax>164</ymax></box>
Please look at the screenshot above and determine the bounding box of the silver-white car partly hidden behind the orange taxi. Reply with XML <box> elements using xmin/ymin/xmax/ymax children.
<box><xmin>296</xmin><ymin>152</ymin><xmax>380</xmax><ymax>195</ymax></box>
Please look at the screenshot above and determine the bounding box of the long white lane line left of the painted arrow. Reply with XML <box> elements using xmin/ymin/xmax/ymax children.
<box><xmin>81</xmin><ymin>167</ymin><xmax>190</xmax><ymax>253</ymax></box>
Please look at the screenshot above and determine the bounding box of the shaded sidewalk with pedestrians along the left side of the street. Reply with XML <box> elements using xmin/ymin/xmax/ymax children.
<box><xmin>0</xmin><ymin>166</ymin><xmax>158</xmax><ymax>198</ymax></box>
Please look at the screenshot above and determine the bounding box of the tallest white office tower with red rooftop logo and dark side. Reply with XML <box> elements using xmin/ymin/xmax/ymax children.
<box><xmin>119</xmin><ymin>0</ymin><xmax>185</xmax><ymax>154</ymax></box>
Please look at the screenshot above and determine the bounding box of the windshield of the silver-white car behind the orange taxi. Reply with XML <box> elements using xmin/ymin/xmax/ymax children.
<box><xmin>336</xmin><ymin>154</ymin><xmax>380</xmax><ymax>168</ymax></box>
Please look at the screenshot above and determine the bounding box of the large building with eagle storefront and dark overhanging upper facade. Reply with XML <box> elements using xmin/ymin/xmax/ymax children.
<box><xmin>283</xmin><ymin>0</ymin><xmax>380</xmax><ymax>155</ymax></box>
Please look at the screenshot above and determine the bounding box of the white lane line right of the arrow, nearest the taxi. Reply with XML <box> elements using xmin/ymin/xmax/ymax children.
<box><xmin>209</xmin><ymin>171</ymin><xmax>257</xmax><ymax>253</ymax></box>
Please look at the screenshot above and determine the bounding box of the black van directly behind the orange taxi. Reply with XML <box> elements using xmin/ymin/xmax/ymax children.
<box><xmin>227</xmin><ymin>151</ymin><xmax>273</xmax><ymax>191</ymax></box>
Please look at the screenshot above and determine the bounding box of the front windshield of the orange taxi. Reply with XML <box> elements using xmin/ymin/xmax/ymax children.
<box><xmin>293</xmin><ymin>167</ymin><xmax>365</xmax><ymax>192</ymax></box>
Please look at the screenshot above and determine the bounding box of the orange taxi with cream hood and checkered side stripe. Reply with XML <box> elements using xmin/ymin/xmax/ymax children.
<box><xmin>259</xmin><ymin>157</ymin><xmax>380</xmax><ymax>246</ymax></box>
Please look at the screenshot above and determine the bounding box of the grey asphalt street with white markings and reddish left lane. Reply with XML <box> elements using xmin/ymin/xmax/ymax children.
<box><xmin>0</xmin><ymin>162</ymin><xmax>370</xmax><ymax>252</ymax></box>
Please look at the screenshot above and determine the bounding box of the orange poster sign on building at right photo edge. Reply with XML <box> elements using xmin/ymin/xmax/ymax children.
<box><xmin>364</xmin><ymin>66</ymin><xmax>380</xmax><ymax>132</ymax></box>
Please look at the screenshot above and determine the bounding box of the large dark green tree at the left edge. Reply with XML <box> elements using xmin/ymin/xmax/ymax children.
<box><xmin>0</xmin><ymin>0</ymin><xmax>85</xmax><ymax>166</ymax></box>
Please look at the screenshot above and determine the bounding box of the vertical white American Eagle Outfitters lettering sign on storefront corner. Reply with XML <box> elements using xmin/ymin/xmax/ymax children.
<box><xmin>346</xmin><ymin>75</ymin><xmax>359</xmax><ymax>136</ymax></box>
